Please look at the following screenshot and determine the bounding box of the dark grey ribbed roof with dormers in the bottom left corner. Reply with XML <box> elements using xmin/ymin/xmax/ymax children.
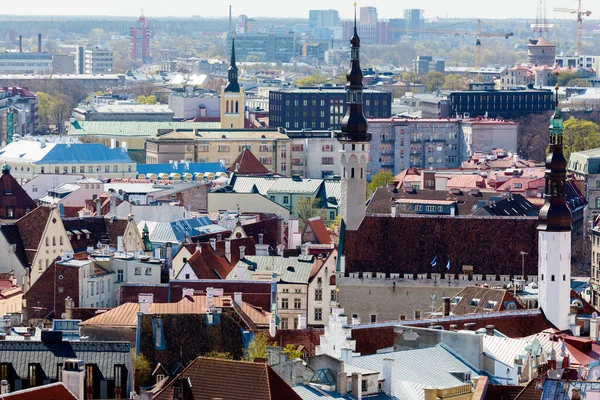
<box><xmin>0</xmin><ymin>341</ymin><xmax>131</xmax><ymax>380</ymax></box>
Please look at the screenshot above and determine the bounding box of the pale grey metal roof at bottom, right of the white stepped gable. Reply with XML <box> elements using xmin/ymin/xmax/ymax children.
<box><xmin>352</xmin><ymin>345</ymin><xmax>479</xmax><ymax>399</ymax></box>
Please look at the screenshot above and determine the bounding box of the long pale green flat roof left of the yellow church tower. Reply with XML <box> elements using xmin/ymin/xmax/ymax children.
<box><xmin>68</xmin><ymin>121</ymin><xmax>221</xmax><ymax>136</ymax></box>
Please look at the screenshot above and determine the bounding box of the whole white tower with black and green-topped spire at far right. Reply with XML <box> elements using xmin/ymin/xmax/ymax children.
<box><xmin>538</xmin><ymin>86</ymin><xmax>572</xmax><ymax>330</ymax></box>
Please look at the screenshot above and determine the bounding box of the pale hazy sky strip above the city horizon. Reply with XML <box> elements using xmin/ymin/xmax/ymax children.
<box><xmin>0</xmin><ymin>0</ymin><xmax>600</xmax><ymax>19</ymax></box>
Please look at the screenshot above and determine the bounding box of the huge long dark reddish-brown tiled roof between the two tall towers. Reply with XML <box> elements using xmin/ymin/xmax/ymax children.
<box><xmin>343</xmin><ymin>215</ymin><xmax>538</xmax><ymax>275</ymax></box>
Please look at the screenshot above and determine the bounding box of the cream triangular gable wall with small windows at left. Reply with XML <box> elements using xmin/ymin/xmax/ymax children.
<box><xmin>29</xmin><ymin>208</ymin><xmax>73</xmax><ymax>285</ymax></box>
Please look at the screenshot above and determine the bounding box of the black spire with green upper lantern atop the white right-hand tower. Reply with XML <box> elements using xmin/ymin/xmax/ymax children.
<box><xmin>538</xmin><ymin>85</ymin><xmax>572</xmax><ymax>232</ymax></box>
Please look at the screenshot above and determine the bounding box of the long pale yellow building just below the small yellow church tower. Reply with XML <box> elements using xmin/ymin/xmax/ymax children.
<box><xmin>146</xmin><ymin>129</ymin><xmax>291</xmax><ymax>175</ymax></box>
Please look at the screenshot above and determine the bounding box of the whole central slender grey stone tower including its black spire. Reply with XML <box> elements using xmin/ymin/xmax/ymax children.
<box><xmin>337</xmin><ymin>5</ymin><xmax>371</xmax><ymax>231</ymax></box>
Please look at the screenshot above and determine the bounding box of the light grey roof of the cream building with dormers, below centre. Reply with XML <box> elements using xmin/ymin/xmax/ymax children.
<box><xmin>226</xmin><ymin>255</ymin><xmax>315</xmax><ymax>283</ymax></box>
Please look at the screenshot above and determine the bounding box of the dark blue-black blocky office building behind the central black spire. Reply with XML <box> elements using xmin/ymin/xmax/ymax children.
<box><xmin>269</xmin><ymin>86</ymin><xmax>392</xmax><ymax>130</ymax></box>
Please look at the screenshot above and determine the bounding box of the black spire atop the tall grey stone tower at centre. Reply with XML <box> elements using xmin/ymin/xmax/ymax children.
<box><xmin>337</xmin><ymin>3</ymin><xmax>371</xmax><ymax>142</ymax></box>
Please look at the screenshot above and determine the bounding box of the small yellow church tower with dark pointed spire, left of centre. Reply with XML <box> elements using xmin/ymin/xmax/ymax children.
<box><xmin>221</xmin><ymin>39</ymin><xmax>246</xmax><ymax>129</ymax></box>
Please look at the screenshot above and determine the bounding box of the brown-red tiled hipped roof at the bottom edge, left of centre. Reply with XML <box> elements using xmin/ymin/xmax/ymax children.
<box><xmin>154</xmin><ymin>357</ymin><xmax>301</xmax><ymax>400</ymax></box>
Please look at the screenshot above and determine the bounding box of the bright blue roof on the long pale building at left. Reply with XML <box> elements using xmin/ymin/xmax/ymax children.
<box><xmin>39</xmin><ymin>143</ymin><xmax>133</xmax><ymax>164</ymax></box>
